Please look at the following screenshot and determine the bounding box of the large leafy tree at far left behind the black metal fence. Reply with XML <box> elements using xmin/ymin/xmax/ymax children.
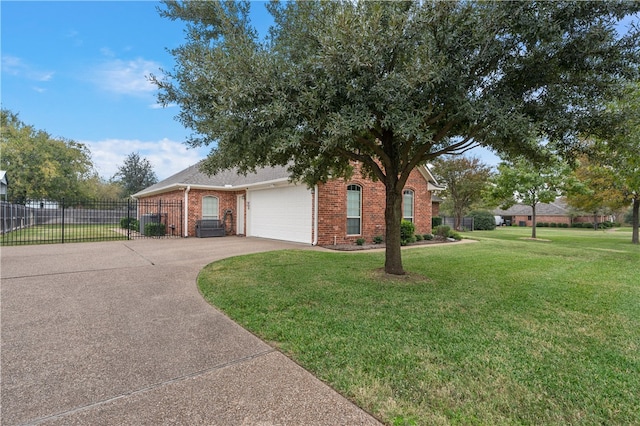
<box><xmin>0</xmin><ymin>109</ymin><xmax>93</xmax><ymax>203</ymax></box>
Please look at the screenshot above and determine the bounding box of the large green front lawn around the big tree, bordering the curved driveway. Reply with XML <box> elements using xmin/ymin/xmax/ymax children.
<box><xmin>199</xmin><ymin>228</ymin><xmax>640</xmax><ymax>425</ymax></box>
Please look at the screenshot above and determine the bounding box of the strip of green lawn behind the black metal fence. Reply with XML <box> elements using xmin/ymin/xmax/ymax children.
<box><xmin>0</xmin><ymin>224</ymin><xmax>127</xmax><ymax>246</ymax></box>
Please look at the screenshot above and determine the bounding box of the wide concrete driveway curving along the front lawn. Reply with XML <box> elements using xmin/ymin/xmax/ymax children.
<box><xmin>0</xmin><ymin>237</ymin><xmax>379</xmax><ymax>425</ymax></box>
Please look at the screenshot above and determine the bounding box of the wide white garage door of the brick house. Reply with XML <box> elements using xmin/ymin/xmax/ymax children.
<box><xmin>247</xmin><ymin>185</ymin><xmax>312</xmax><ymax>244</ymax></box>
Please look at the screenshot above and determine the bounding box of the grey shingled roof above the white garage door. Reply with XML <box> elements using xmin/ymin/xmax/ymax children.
<box><xmin>133</xmin><ymin>163</ymin><xmax>289</xmax><ymax>198</ymax></box>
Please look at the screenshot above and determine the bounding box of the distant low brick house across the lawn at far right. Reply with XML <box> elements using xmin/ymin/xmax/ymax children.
<box><xmin>493</xmin><ymin>198</ymin><xmax>610</xmax><ymax>226</ymax></box>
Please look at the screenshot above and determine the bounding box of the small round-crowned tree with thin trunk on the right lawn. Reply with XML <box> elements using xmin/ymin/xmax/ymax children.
<box><xmin>488</xmin><ymin>157</ymin><xmax>570</xmax><ymax>238</ymax></box>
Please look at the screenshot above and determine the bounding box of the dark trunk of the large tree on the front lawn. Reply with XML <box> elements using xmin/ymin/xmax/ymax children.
<box><xmin>384</xmin><ymin>182</ymin><xmax>405</xmax><ymax>275</ymax></box>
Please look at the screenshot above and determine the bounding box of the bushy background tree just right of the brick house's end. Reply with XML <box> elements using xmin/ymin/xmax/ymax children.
<box><xmin>432</xmin><ymin>157</ymin><xmax>491</xmax><ymax>231</ymax></box>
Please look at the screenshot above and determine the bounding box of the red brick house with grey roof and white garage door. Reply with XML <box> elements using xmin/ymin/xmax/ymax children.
<box><xmin>133</xmin><ymin>164</ymin><xmax>442</xmax><ymax>245</ymax></box>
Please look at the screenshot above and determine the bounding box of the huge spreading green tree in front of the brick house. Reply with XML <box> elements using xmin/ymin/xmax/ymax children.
<box><xmin>152</xmin><ymin>1</ymin><xmax>640</xmax><ymax>274</ymax></box>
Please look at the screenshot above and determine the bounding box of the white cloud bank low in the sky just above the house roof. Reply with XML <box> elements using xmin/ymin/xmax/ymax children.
<box><xmin>81</xmin><ymin>138</ymin><xmax>207</xmax><ymax>180</ymax></box>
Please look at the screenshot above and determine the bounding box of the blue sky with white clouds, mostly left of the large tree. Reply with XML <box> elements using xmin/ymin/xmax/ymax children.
<box><xmin>0</xmin><ymin>0</ymin><xmax>636</xmax><ymax>179</ymax></box>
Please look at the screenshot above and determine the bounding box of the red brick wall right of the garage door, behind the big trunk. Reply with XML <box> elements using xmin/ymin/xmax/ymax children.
<box><xmin>318</xmin><ymin>165</ymin><xmax>431</xmax><ymax>245</ymax></box>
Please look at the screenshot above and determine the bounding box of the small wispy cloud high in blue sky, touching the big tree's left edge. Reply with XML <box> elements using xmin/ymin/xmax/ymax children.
<box><xmin>92</xmin><ymin>58</ymin><xmax>161</xmax><ymax>96</ymax></box>
